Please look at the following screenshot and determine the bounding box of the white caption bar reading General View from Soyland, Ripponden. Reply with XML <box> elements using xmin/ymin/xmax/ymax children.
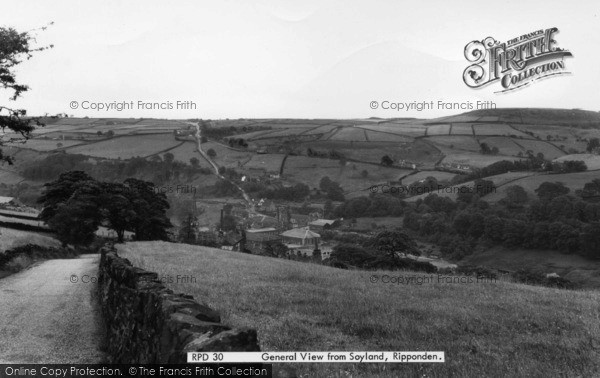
<box><xmin>188</xmin><ymin>351</ymin><xmax>445</xmax><ymax>363</ymax></box>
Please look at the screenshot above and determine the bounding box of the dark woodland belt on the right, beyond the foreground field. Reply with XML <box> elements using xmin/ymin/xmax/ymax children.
<box><xmin>334</xmin><ymin>179</ymin><xmax>600</xmax><ymax>259</ymax></box>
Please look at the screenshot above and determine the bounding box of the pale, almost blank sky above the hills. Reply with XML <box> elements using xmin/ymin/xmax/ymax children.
<box><xmin>0</xmin><ymin>0</ymin><xmax>600</xmax><ymax>119</ymax></box>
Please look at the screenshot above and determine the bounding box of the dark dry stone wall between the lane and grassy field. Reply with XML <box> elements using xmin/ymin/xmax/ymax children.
<box><xmin>98</xmin><ymin>245</ymin><xmax>260</xmax><ymax>363</ymax></box>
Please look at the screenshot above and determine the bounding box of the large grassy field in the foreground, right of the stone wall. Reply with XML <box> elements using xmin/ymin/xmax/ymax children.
<box><xmin>118</xmin><ymin>242</ymin><xmax>600</xmax><ymax>377</ymax></box>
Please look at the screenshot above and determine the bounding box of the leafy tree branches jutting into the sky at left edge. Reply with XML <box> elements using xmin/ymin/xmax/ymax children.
<box><xmin>0</xmin><ymin>27</ymin><xmax>53</xmax><ymax>164</ymax></box>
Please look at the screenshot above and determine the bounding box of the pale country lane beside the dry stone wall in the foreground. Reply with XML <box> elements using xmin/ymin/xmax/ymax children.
<box><xmin>0</xmin><ymin>255</ymin><xmax>105</xmax><ymax>363</ymax></box>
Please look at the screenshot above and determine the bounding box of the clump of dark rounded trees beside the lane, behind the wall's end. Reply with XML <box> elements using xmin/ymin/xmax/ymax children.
<box><xmin>38</xmin><ymin>171</ymin><xmax>172</xmax><ymax>246</ymax></box>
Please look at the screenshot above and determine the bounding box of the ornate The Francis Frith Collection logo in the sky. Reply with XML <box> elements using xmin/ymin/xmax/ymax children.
<box><xmin>463</xmin><ymin>28</ymin><xmax>573</xmax><ymax>93</ymax></box>
